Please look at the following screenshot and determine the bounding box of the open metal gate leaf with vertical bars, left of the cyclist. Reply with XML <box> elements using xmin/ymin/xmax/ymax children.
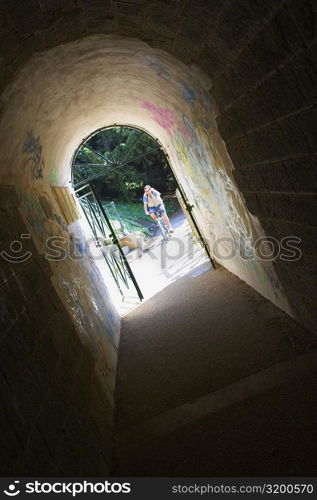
<box><xmin>75</xmin><ymin>183</ymin><xmax>143</xmax><ymax>301</ymax></box>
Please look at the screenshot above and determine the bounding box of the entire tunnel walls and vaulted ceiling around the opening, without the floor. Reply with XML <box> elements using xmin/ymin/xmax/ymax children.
<box><xmin>0</xmin><ymin>0</ymin><xmax>317</xmax><ymax>476</ymax></box>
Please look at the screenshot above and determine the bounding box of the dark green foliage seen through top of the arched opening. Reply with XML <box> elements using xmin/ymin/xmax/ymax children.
<box><xmin>73</xmin><ymin>127</ymin><xmax>176</xmax><ymax>201</ymax></box>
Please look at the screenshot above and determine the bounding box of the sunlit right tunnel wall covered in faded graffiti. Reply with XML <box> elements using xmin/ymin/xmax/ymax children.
<box><xmin>138</xmin><ymin>70</ymin><xmax>291</xmax><ymax>314</ymax></box>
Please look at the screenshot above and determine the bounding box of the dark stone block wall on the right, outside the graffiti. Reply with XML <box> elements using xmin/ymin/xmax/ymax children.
<box><xmin>211</xmin><ymin>0</ymin><xmax>317</xmax><ymax>331</ymax></box>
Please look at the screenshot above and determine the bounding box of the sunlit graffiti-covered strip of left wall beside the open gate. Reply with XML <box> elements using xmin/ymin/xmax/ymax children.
<box><xmin>18</xmin><ymin>132</ymin><xmax>120</xmax><ymax>366</ymax></box>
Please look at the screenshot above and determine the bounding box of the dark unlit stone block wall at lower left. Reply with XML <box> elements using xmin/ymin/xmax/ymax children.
<box><xmin>0</xmin><ymin>187</ymin><xmax>113</xmax><ymax>476</ymax></box>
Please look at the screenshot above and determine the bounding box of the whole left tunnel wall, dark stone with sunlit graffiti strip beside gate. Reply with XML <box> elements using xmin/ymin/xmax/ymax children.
<box><xmin>0</xmin><ymin>68</ymin><xmax>120</xmax><ymax>476</ymax></box>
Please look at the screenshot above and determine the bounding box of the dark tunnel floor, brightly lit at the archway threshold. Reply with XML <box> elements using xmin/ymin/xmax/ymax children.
<box><xmin>113</xmin><ymin>268</ymin><xmax>317</xmax><ymax>476</ymax></box>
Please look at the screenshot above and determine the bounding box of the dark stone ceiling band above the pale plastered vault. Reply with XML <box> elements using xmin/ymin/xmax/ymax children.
<box><xmin>0</xmin><ymin>0</ymin><xmax>283</xmax><ymax>95</ymax></box>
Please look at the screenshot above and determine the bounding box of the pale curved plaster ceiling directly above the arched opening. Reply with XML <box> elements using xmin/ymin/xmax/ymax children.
<box><xmin>0</xmin><ymin>34</ymin><xmax>215</xmax><ymax>185</ymax></box>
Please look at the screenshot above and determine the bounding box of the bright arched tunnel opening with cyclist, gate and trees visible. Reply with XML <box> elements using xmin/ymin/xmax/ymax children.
<box><xmin>72</xmin><ymin>125</ymin><xmax>214</xmax><ymax>313</ymax></box>
